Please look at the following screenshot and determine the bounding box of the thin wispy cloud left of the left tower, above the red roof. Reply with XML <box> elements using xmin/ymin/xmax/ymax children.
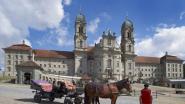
<box><xmin>37</xmin><ymin>13</ymin><xmax>74</xmax><ymax>47</ymax></box>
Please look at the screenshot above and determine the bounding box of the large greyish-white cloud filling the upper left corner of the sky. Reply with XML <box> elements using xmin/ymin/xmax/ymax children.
<box><xmin>0</xmin><ymin>0</ymin><xmax>71</xmax><ymax>70</ymax></box>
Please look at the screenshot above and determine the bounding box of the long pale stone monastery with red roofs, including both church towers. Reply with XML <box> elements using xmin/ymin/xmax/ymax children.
<box><xmin>3</xmin><ymin>13</ymin><xmax>183</xmax><ymax>87</ymax></box>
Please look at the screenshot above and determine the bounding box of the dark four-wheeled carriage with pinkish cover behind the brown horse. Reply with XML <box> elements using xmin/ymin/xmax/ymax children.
<box><xmin>31</xmin><ymin>80</ymin><xmax>83</xmax><ymax>104</ymax></box>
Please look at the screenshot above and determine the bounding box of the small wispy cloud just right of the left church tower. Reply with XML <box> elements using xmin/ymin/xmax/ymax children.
<box><xmin>87</xmin><ymin>17</ymin><xmax>100</xmax><ymax>33</ymax></box>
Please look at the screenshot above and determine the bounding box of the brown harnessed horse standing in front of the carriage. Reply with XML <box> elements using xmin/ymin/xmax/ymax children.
<box><xmin>84</xmin><ymin>79</ymin><xmax>132</xmax><ymax>104</ymax></box>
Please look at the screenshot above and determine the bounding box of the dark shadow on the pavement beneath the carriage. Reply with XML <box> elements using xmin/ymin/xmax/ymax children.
<box><xmin>15</xmin><ymin>98</ymin><xmax>63</xmax><ymax>104</ymax></box>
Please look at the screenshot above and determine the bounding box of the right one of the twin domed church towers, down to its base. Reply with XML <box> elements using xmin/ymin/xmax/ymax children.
<box><xmin>121</xmin><ymin>18</ymin><xmax>136</xmax><ymax>79</ymax></box>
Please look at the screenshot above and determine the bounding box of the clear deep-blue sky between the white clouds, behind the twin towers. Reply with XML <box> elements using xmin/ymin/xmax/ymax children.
<box><xmin>28</xmin><ymin>0</ymin><xmax>185</xmax><ymax>50</ymax></box>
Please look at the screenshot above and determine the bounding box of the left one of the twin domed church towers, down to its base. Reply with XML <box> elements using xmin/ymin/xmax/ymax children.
<box><xmin>74</xmin><ymin>13</ymin><xmax>87</xmax><ymax>76</ymax></box>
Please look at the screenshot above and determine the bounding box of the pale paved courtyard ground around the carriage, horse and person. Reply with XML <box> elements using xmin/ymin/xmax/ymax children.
<box><xmin>0</xmin><ymin>83</ymin><xmax>185</xmax><ymax>104</ymax></box>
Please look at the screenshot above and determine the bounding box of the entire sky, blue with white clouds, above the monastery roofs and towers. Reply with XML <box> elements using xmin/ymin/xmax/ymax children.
<box><xmin>0</xmin><ymin>0</ymin><xmax>185</xmax><ymax>67</ymax></box>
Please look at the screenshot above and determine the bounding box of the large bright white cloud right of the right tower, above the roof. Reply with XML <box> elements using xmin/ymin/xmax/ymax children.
<box><xmin>135</xmin><ymin>26</ymin><xmax>185</xmax><ymax>59</ymax></box>
